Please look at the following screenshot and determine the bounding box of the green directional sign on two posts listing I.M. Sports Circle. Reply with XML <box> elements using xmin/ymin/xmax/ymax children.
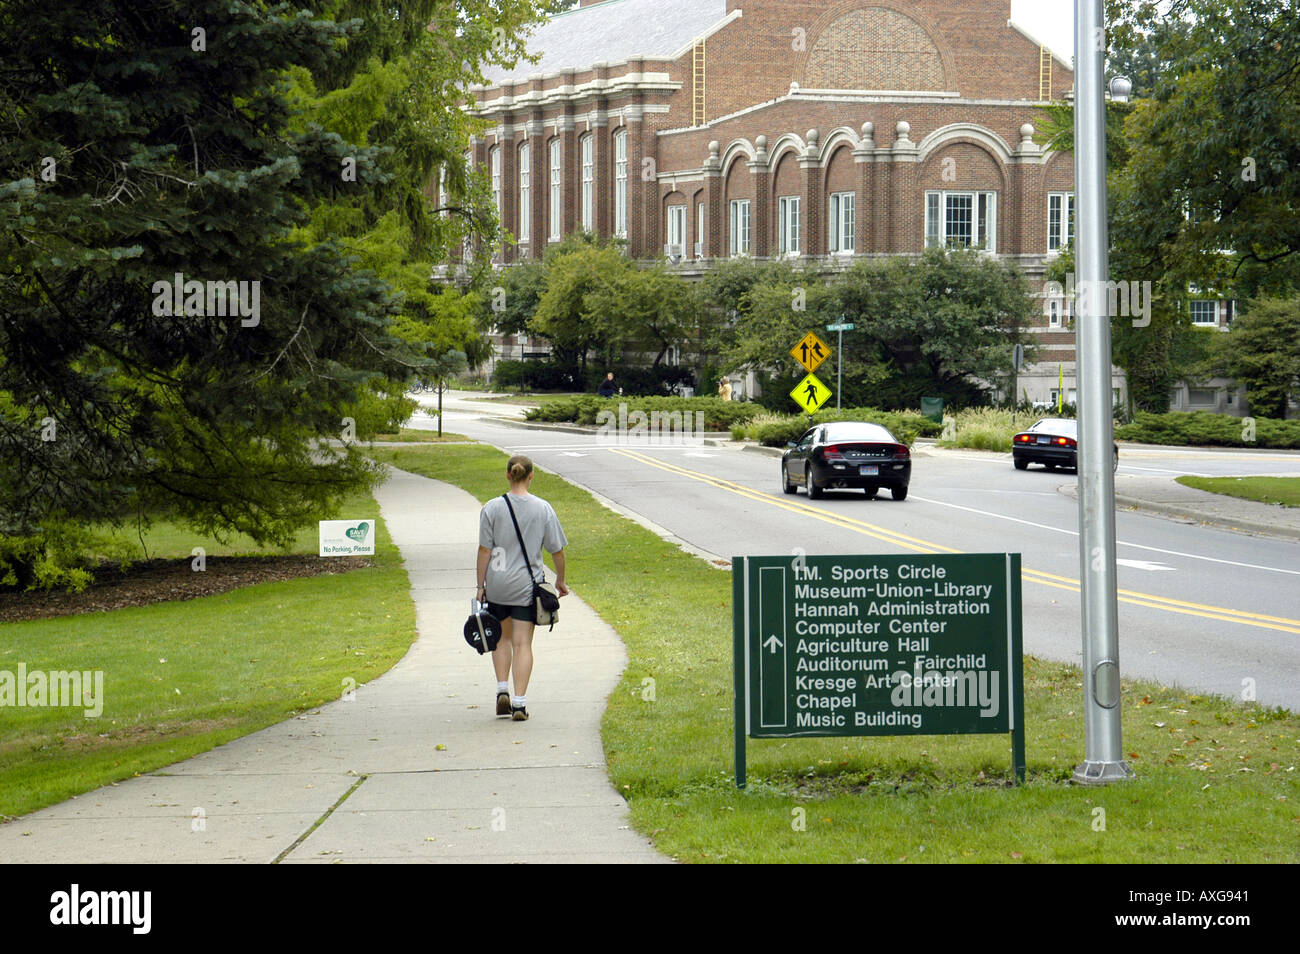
<box><xmin>732</xmin><ymin>554</ymin><xmax>1024</xmax><ymax>788</ymax></box>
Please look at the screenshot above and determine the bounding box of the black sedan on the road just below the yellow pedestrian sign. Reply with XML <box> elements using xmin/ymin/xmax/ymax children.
<box><xmin>781</xmin><ymin>421</ymin><xmax>911</xmax><ymax>500</ymax></box>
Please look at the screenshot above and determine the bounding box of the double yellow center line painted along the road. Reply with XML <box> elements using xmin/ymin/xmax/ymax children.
<box><xmin>611</xmin><ymin>447</ymin><xmax>1300</xmax><ymax>634</ymax></box>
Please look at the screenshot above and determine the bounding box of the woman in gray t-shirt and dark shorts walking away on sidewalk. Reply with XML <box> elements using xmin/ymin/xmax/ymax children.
<box><xmin>478</xmin><ymin>455</ymin><xmax>568</xmax><ymax>721</ymax></box>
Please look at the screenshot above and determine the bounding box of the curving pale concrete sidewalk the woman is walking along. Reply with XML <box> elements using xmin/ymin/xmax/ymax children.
<box><xmin>0</xmin><ymin>471</ymin><xmax>667</xmax><ymax>863</ymax></box>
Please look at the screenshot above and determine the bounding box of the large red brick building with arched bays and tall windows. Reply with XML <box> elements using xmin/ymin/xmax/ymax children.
<box><xmin>471</xmin><ymin>0</ymin><xmax>1122</xmax><ymax>400</ymax></box>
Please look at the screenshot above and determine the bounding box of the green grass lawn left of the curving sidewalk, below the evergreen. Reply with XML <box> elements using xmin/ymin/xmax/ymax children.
<box><xmin>0</xmin><ymin>494</ymin><xmax>415</xmax><ymax>815</ymax></box>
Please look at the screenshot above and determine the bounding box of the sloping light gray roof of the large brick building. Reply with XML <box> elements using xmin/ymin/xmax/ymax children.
<box><xmin>485</xmin><ymin>0</ymin><xmax>727</xmax><ymax>86</ymax></box>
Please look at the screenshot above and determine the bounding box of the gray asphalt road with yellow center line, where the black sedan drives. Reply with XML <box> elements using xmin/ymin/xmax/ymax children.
<box><xmin>413</xmin><ymin>398</ymin><xmax>1300</xmax><ymax>711</ymax></box>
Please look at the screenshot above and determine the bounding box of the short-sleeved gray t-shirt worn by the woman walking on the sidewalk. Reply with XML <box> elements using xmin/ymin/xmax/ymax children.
<box><xmin>478</xmin><ymin>494</ymin><xmax>568</xmax><ymax>606</ymax></box>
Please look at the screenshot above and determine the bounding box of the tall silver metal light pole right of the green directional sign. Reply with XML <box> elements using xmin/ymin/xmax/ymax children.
<box><xmin>1074</xmin><ymin>0</ymin><xmax>1134</xmax><ymax>785</ymax></box>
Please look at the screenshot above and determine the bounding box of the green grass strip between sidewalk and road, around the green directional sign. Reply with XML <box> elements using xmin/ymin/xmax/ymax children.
<box><xmin>373</xmin><ymin>447</ymin><xmax>1300</xmax><ymax>863</ymax></box>
